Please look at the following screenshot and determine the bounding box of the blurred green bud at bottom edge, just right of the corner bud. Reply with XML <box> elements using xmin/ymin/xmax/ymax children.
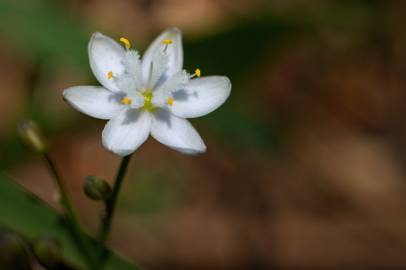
<box><xmin>32</xmin><ymin>236</ymin><xmax>61</xmax><ymax>269</ymax></box>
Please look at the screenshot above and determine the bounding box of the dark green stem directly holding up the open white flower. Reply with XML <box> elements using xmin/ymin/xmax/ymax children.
<box><xmin>98</xmin><ymin>155</ymin><xmax>132</xmax><ymax>264</ymax></box>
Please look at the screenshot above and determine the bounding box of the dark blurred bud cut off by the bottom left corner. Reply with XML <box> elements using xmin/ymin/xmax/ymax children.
<box><xmin>0</xmin><ymin>230</ymin><xmax>31</xmax><ymax>269</ymax></box>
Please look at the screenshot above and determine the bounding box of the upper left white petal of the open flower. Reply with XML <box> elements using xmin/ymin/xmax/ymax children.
<box><xmin>88</xmin><ymin>33</ymin><xmax>126</xmax><ymax>91</ymax></box>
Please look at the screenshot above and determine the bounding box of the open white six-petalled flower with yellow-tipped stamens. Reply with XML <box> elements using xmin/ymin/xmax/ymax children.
<box><xmin>63</xmin><ymin>28</ymin><xmax>231</xmax><ymax>156</ymax></box>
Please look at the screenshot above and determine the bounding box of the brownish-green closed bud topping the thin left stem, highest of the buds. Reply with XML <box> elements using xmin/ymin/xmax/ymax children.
<box><xmin>18</xmin><ymin>120</ymin><xmax>47</xmax><ymax>153</ymax></box>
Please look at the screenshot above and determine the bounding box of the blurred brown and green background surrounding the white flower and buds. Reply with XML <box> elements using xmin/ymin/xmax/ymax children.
<box><xmin>0</xmin><ymin>0</ymin><xmax>406</xmax><ymax>269</ymax></box>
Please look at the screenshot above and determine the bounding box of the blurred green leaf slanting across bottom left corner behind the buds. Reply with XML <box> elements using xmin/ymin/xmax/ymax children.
<box><xmin>0</xmin><ymin>174</ymin><xmax>140</xmax><ymax>270</ymax></box>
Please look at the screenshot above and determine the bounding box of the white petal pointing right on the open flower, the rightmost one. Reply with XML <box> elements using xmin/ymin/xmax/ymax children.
<box><xmin>168</xmin><ymin>76</ymin><xmax>231</xmax><ymax>118</ymax></box>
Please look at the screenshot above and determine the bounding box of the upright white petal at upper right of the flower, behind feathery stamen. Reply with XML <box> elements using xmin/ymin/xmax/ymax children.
<box><xmin>142</xmin><ymin>28</ymin><xmax>183</xmax><ymax>81</ymax></box>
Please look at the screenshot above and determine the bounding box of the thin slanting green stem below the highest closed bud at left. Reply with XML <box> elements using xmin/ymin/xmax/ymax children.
<box><xmin>43</xmin><ymin>152</ymin><xmax>97</xmax><ymax>270</ymax></box>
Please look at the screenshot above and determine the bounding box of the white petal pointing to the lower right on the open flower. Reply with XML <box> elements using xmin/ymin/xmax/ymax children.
<box><xmin>151</xmin><ymin>109</ymin><xmax>206</xmax><ymax>154</ymax></box>
